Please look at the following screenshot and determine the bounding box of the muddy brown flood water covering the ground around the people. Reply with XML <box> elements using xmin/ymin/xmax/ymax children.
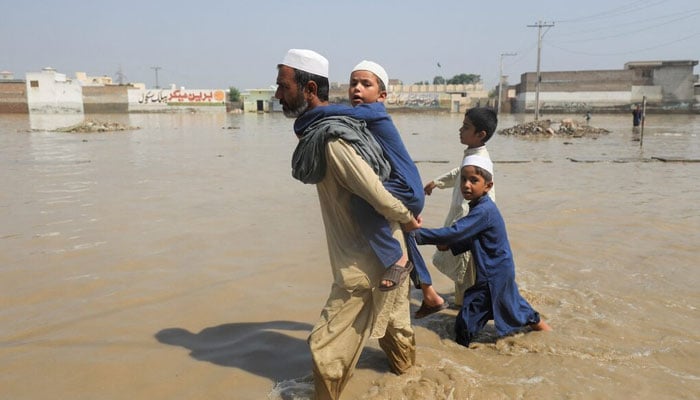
<box><xmin>0</xmin><ymin>110</ymin><xmax>700</xmax><ymax>400</ymax></box>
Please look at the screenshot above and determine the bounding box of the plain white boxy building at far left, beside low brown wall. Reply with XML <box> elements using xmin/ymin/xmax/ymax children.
<box><xmin>25</xmin><ymin>68</ymin><xmax>83</xmax><ymax>114</ymax></box>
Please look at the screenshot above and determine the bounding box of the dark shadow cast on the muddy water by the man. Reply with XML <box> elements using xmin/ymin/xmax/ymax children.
<box><xmin>155</xmin><ymin>321</ymin><xmax>389</xmax><ymax>381</ymax></box>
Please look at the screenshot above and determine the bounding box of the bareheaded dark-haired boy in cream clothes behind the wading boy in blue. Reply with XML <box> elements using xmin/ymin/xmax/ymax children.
<box><xmin>423</xmin><ymin>107</ymin><xmax>498</xmax><ymax>307</ymax></box>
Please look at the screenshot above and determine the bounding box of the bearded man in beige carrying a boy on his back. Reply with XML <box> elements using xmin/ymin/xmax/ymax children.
<box><xmin>275</xmin><ymin>49</ymin><xmax>420</xmax><ymax>400</ymax></box>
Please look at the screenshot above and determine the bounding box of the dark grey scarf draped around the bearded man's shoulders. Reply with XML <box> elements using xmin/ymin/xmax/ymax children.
<box><xmin>292</xmin><ymin>116</ymin><xmax>391</xmax><ymax>184</ymax></box>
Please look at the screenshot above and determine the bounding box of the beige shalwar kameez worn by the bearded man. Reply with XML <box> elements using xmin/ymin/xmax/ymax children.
<box><xmin>308</xmin><ymin>139</ymin><xmax>415</xmax><ymax>400</ymax></box>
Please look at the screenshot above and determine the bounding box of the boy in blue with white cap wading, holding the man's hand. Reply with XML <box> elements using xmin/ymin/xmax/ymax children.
<box><xmin>416</xmin><ymin>155</ymin><xmax>551</xmax><ymax>346</ymax></box>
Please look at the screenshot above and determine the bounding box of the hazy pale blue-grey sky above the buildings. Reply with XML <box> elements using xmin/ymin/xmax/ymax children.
<box><xmin>0</xmin><ymin>0</ymin><xmax>700</xmax><ymax>91</ymax></box>
